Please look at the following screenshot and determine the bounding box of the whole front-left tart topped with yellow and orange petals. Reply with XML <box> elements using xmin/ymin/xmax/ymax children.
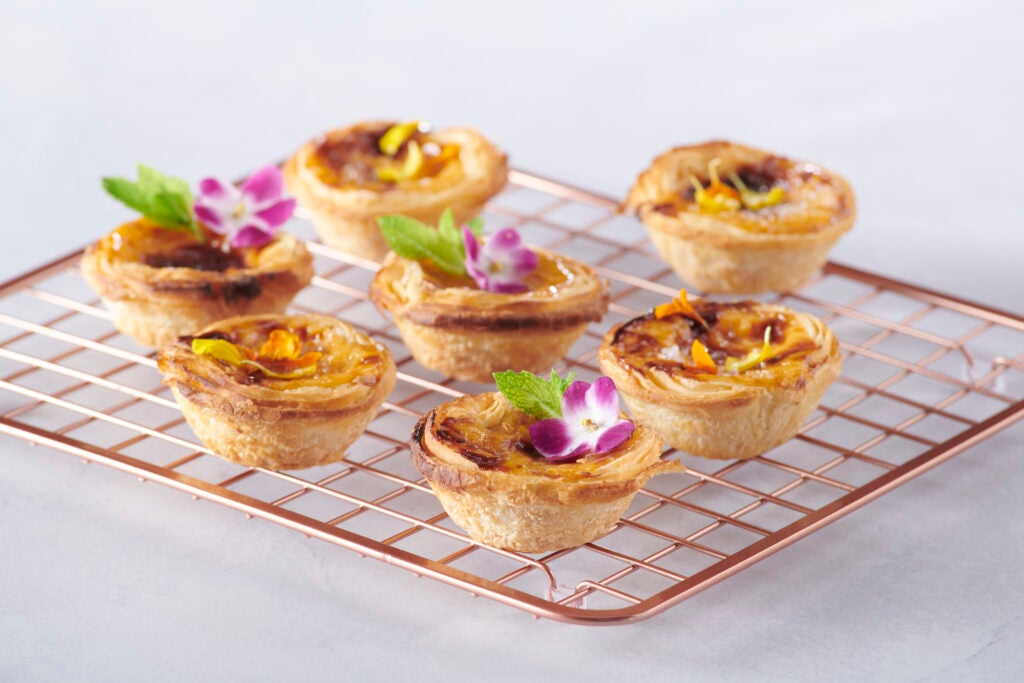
<box><xmin>158</xmin><ymin>314</ymin><xmax>395</xmax><ymax>470</ymax></box>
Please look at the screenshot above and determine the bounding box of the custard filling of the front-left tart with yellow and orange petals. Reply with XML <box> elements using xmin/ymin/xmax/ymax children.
<box><xmin>192</xmin><ymin>321</ymin><xmax>386</xmax><ymax>391</ymax></box>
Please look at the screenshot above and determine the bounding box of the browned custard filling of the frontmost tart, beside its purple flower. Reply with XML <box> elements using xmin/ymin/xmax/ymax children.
<box><xmin>428</xmin><ymin>400</ymin><xmax>637</xmax><ymax>481</ymax></box>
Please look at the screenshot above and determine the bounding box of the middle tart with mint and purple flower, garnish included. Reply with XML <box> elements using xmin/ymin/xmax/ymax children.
<box><xmin>370</xmin><ymin>211</ymin><xmax>608</xmax><ymax>382</ymax></box>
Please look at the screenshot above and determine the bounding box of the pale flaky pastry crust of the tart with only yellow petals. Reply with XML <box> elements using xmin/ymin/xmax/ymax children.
<box><xmin>283</xmin><ymin>121</ymin><xmax>508</xmax><ymax>261</ymax></box>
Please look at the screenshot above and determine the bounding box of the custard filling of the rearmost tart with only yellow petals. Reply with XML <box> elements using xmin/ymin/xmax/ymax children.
<box><xmin>309</xmin><ymin>123</ymin><xmax>464</xmax><ymax>191</ymax></box>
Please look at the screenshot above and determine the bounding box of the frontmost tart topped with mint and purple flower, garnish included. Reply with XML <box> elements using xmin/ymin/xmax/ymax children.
<box><xmin>412</xmin><ymin>372</ymin><xmax>684</xmax><ymax>553</ymax></box>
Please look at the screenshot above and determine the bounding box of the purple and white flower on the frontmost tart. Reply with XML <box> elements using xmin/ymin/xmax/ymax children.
<box><xmin>529</xmin><ymin>377</ymin><xmax>633</xmax><ymax>461</ymax></box>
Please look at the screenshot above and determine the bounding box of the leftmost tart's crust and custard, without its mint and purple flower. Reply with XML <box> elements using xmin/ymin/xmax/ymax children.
<box><xmin>81</xmin><ymin>218</ymin><xmax>313</xmax><ymax>347</ymax></box>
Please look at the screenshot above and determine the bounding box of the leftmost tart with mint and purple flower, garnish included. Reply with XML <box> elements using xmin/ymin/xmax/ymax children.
<box><xmin>82</xmin><ymin>165</ymin><xmax>313</xmax><ymax>347</ymax></box>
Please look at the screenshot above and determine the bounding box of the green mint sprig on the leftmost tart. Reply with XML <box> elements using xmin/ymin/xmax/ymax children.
<box><xmin>103</xmin><ymin>164</ymin><xmax>205</xmax><ymax>242</ymax></box>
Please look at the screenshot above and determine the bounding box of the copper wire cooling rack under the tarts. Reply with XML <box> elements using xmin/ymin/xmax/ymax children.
<box><xmin>0</xmin><ymin>172</ymin><xmax>1024</xmax><ymax>624</ymax></box>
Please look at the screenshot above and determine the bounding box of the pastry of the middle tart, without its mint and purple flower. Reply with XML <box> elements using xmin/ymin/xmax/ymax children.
<box><xmin>370</xmin><ymin>247</ymin><xmax>609</xmax><ymax>382</ymax></box>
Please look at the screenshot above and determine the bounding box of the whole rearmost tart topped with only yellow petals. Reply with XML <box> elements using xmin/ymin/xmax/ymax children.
<box><xmin>285</xmin><ymin>121</ymin><xmax>508</xmax><ymax>262</ymax></box>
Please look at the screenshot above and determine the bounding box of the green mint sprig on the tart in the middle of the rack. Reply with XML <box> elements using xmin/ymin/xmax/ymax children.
<box><xmin>377</xmin><ymin>209</ymin><xmax>483</xmax><ymax>275</ymax></box>
